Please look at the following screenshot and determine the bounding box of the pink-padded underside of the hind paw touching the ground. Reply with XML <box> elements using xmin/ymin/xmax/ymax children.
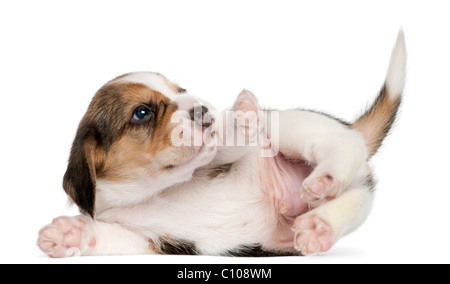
<box><xmin>292</xmin><ymin>214</ymin><xmax>334</xmax><ymax>255</ymax></box>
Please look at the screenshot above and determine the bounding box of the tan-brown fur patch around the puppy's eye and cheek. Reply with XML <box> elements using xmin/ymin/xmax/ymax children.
<box><xmin>94</xmin><ymin>83</ymin><xmax>192</xmax><ymax>182</ymax></box>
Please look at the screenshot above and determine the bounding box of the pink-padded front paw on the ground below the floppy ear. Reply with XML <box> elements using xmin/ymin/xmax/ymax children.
<box><xmin>37</xmin><ymin>216</ymin><xmax>96</xmax><ymax>258</ymax></box>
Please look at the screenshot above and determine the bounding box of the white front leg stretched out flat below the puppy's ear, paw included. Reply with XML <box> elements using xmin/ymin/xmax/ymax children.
<box><xmin>37</xmin><ymin>216</ymin><xmax>152</xmax><ymax>258</ymax></box>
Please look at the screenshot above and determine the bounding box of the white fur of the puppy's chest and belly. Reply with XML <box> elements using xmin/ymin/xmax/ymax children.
<box><xmin>97</xmin><ymin>149</ymin><xmax>275</xmax><ymax>254</ymax></box>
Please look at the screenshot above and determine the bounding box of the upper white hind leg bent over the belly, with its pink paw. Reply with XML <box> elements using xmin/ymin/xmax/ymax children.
<box><xmin>267</xmin><ymin>111</ymin><xmax>367</xmax><ymax>207</ymax></box>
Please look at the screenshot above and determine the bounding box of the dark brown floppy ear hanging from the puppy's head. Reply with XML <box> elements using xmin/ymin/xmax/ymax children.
<box><xmin>63</xmin><ymin>124</ymin><xmax>104</xmax><ymax>217</ymax></box>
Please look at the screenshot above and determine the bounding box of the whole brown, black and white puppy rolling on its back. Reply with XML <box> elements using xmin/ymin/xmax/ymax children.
<box><xmin>38</xmin><ymin>32</ymin><xmax>406</xmax><ymax>257</ymax></box>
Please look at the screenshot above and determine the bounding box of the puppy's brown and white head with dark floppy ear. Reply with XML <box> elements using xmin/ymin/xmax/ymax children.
<box><xmin>63</xmin><ymin>72</ymin><xmax>216</xmax><ymax>216</ymax></box>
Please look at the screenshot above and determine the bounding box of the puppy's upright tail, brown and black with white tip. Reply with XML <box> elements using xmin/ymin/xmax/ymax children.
<box><xmin>351</xmin><ymin>30</ymin><xmax>406</xmax><ymax>158</ymax></box>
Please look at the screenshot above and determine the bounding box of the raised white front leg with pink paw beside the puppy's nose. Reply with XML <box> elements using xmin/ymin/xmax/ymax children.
<box><xmin>214</xmin><ymin>90</ymin><xmax>264</xmax><ymax>165</ymax></box>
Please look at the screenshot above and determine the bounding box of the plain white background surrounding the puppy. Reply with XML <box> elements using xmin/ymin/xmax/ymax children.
<box><xmin>0</xmin><ymin>0</ymin><xmax>450</xmax><ymax>263</ymax></box>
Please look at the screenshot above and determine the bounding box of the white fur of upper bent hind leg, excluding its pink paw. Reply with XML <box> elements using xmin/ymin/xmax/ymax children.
<box><xmin>268</xmin><ymin>111</ymin><xmax>367</xmax><ymax>191</ymax></box>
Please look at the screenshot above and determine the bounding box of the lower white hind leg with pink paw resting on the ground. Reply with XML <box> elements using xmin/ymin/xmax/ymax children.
<box><xmin>292</xmin><ymin>186</ymin><xmax>372</xmax><ymax>255</ymax></box>
